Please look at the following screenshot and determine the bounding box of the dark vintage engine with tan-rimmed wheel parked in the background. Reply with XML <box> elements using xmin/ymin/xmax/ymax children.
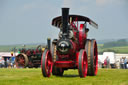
<box><xmin>15</xmin><ymin>45</ymin><xmax>43</xmax><ymax>68</ymax></box>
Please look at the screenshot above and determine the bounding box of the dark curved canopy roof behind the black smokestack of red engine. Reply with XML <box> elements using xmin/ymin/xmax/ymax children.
<box><xmin>52</xmin><ymin>15</ymin><xmax>98</xmax><ymax>28</ymax></box>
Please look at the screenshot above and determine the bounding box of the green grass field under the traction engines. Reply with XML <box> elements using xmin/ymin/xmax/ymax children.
<box><xmin>0</xmin><ymin>68</ymin><xmax>128</xmax><ymax>85</ymax></box>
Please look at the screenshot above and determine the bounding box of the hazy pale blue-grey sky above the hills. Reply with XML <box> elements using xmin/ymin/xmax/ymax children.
<box><xmin>0</xmin><ymin>0</ymin><xmax>128</xmax><ymax>45</ymax></box>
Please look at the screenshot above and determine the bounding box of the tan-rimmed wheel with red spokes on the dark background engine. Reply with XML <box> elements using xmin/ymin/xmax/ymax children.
<box><xmin>15</xmin><ymin>53</ymin><xmax>28</xmax><ymax>68</ymax></box>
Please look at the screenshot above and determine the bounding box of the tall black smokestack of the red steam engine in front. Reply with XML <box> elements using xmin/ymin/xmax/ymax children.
<box><xmin>61</xmin><ymin>8</ymin><xmax>69</xmax><ymax>35</ymax></box>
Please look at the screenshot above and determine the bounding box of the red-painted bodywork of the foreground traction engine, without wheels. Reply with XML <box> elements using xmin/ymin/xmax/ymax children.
<box><xmin>54</xmin><ymin>18</ymin><xmax>86</xmax><ymax>68</ymax></box>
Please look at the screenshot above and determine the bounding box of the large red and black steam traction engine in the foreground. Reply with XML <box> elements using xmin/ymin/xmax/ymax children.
<box><xmin>41</xmin><ymin>8</ymin><xmax>98</xmax><ymax>77</ymax></box>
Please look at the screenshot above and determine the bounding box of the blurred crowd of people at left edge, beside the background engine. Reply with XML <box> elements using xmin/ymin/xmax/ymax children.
<box><xmin>0</xmin><ymin>58</ymin><xmax>15</xmax><ymax>68</ymax></box>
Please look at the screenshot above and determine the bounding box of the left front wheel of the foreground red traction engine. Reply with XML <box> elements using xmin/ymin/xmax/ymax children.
<box><xmin>41</xmin><ymin>49</ymin><xmax>53</xmax><ymax>77</ymax></box>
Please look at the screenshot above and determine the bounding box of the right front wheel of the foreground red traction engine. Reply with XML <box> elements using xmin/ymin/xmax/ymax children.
<box><xmin>78</xmin><ymin>50</ymin><xmax>88</xmax><ymax>77</ymax></box>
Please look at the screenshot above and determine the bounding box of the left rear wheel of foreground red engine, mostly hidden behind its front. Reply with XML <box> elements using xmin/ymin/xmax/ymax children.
<box><xmin>52</xmin><ymin>44</ymin><xmax>64</xmax><ymax>76</ymax></box>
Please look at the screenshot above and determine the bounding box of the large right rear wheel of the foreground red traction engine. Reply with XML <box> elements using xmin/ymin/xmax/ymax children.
<box><xmin>85</xmin><ymin>39</ymin><xmax>98</xmax><ymax>76</ymax></box>
